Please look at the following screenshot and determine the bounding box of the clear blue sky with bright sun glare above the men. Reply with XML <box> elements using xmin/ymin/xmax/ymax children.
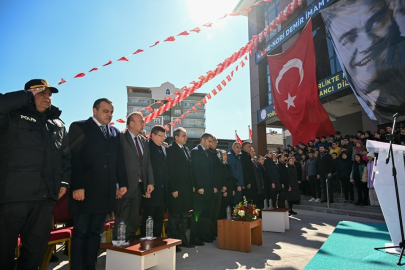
<box><xmin>0</xmin><ymin>0</ymin><xmax>251</xmax><ymax>139</ymax></box>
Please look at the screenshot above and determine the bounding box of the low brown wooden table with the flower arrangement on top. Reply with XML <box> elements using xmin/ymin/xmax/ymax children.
<box><xmin>217</xmin><ymin>218</ymin><xmax>263</xmax><ymax>252</ymax></box>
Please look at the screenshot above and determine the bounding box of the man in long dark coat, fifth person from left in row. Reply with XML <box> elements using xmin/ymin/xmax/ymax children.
<box><xmin>166</xmin><ymin>127</ymin><xmax>194</xmax><ymax>251</ymax></box>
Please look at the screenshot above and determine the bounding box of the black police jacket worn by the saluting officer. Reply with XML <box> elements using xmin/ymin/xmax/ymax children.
<box><xmin>0</xmin><ymin>90</ymin><xmax>70</xmax><ymax>204</ymax></box>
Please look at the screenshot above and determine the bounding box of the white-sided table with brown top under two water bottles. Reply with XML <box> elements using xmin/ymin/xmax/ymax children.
<box><xmin>100</xmin><ymin>237</ymin><xmax>181</xmax><ymax>270</ymax></box>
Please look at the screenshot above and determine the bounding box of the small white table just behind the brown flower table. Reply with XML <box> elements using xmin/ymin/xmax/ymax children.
<box><xmin>260</xmin><ymin>208</ymin><xmax>290</xmax><ymax>233</ymax></box>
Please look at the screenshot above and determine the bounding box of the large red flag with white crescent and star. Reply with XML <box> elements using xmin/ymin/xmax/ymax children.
<box><xmin>267</xmin><ymin>20</ymin><xmax>335</xmax><ymax>145</ymax></box>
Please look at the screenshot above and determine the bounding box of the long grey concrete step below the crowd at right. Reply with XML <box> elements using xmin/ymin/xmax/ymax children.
<box><xmin>294</xmin><ymin>204</ymin><xmax>384</xmax><ymax>220</ymax></box>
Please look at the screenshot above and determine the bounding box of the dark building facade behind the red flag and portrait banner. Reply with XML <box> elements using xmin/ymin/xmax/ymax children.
<box><xmin>235</xmin><ymin>0</ymin><xmax>377</xmax><ymax>153</ymax></box>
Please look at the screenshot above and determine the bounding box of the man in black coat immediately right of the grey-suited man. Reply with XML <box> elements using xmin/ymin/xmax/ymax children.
<box><xmin>141</xmin><ymin>125</ymin><xmax>168</xmax><ymax>237</ymax></box>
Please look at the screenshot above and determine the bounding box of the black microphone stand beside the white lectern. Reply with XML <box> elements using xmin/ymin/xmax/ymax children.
<box><xmin>374</xmin><ymin>113</ymin><xmax>405</xmax><ymax>265</ymax></box>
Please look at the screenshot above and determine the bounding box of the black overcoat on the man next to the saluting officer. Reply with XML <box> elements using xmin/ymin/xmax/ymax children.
<box><xmin>68</xmin><ymin>117</ymin><xmax>128</xmax><ymax>214</ymax></box>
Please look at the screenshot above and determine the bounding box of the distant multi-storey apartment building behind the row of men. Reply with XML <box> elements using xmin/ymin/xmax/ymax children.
<box><xmin>127</xmin><ymin>82</ymin><xmax>206</xmax><ymax>138</ymax></box>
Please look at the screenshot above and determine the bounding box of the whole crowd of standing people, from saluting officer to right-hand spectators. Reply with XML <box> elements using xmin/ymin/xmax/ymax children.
<box><xmin>0</xmin><ymin>79</ymin><xmax>405</xmax><ymax>270</ymax></box>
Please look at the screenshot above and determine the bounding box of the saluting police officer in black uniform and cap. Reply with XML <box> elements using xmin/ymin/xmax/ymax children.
<box><xmin>0</xmin><ymin>79</ymin><xmax>70</xmax><ymax>269</ymax></box>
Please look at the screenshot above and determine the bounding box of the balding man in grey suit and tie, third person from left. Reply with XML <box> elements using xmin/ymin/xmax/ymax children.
<box><xmin>113</xmin><ymin>112</ymin><xmax>154</xmax><ymax>241</ymax></box>
